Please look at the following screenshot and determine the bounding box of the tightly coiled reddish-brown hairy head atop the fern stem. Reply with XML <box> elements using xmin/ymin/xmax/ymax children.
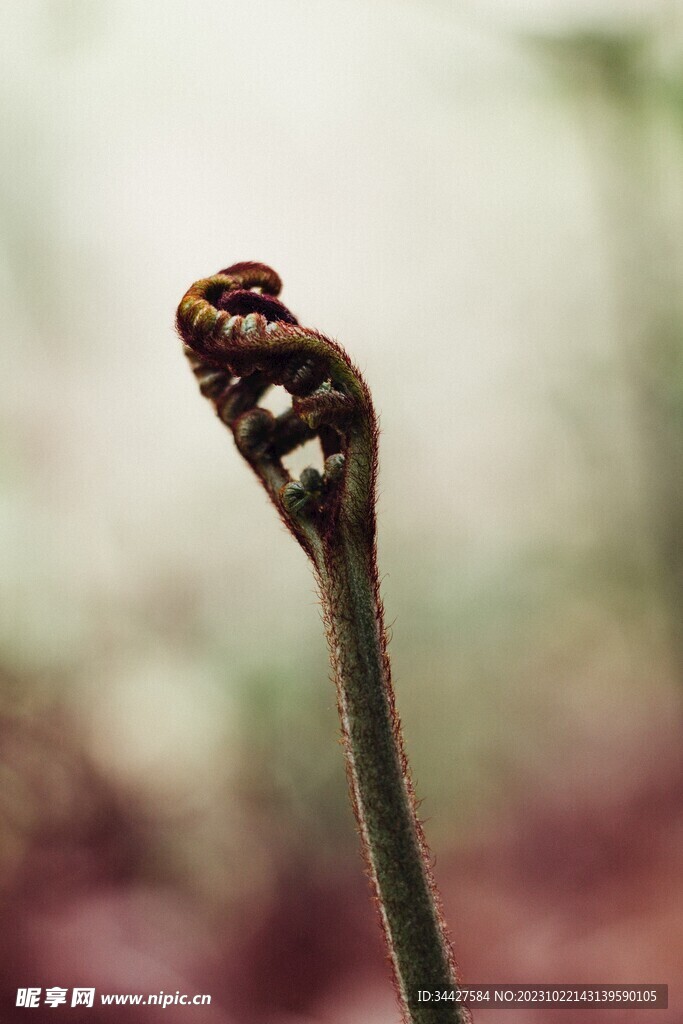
<box><xmin>172</xmin><ymin>263</ymin><xmax>377</xmax><ymax>556</ymax></box>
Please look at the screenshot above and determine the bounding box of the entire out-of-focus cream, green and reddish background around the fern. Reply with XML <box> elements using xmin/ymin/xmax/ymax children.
<box><xmin>0</xmin><ymin>0</ymin><xmax>683</xmax><ymax>1024</ymax></box>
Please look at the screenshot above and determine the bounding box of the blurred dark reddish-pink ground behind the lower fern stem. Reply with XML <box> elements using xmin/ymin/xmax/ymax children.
<box><xmin>0</xmin><ymin>712</ymin><xmax>683</xmax><ymax>1024</ymax></box>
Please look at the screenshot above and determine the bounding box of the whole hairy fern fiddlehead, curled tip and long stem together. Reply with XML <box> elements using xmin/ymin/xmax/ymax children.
<box><xmin>177</xmin><ymin>263</ymin><xmax>471</xmax><ymax>1024</ymax></box>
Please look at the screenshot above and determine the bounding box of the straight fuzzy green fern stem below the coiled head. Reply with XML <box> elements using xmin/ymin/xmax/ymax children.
<box><xmin>315</xmin><ymin>530</ymin><xmax>471</xmax><ymax>1024</ymax></box>
